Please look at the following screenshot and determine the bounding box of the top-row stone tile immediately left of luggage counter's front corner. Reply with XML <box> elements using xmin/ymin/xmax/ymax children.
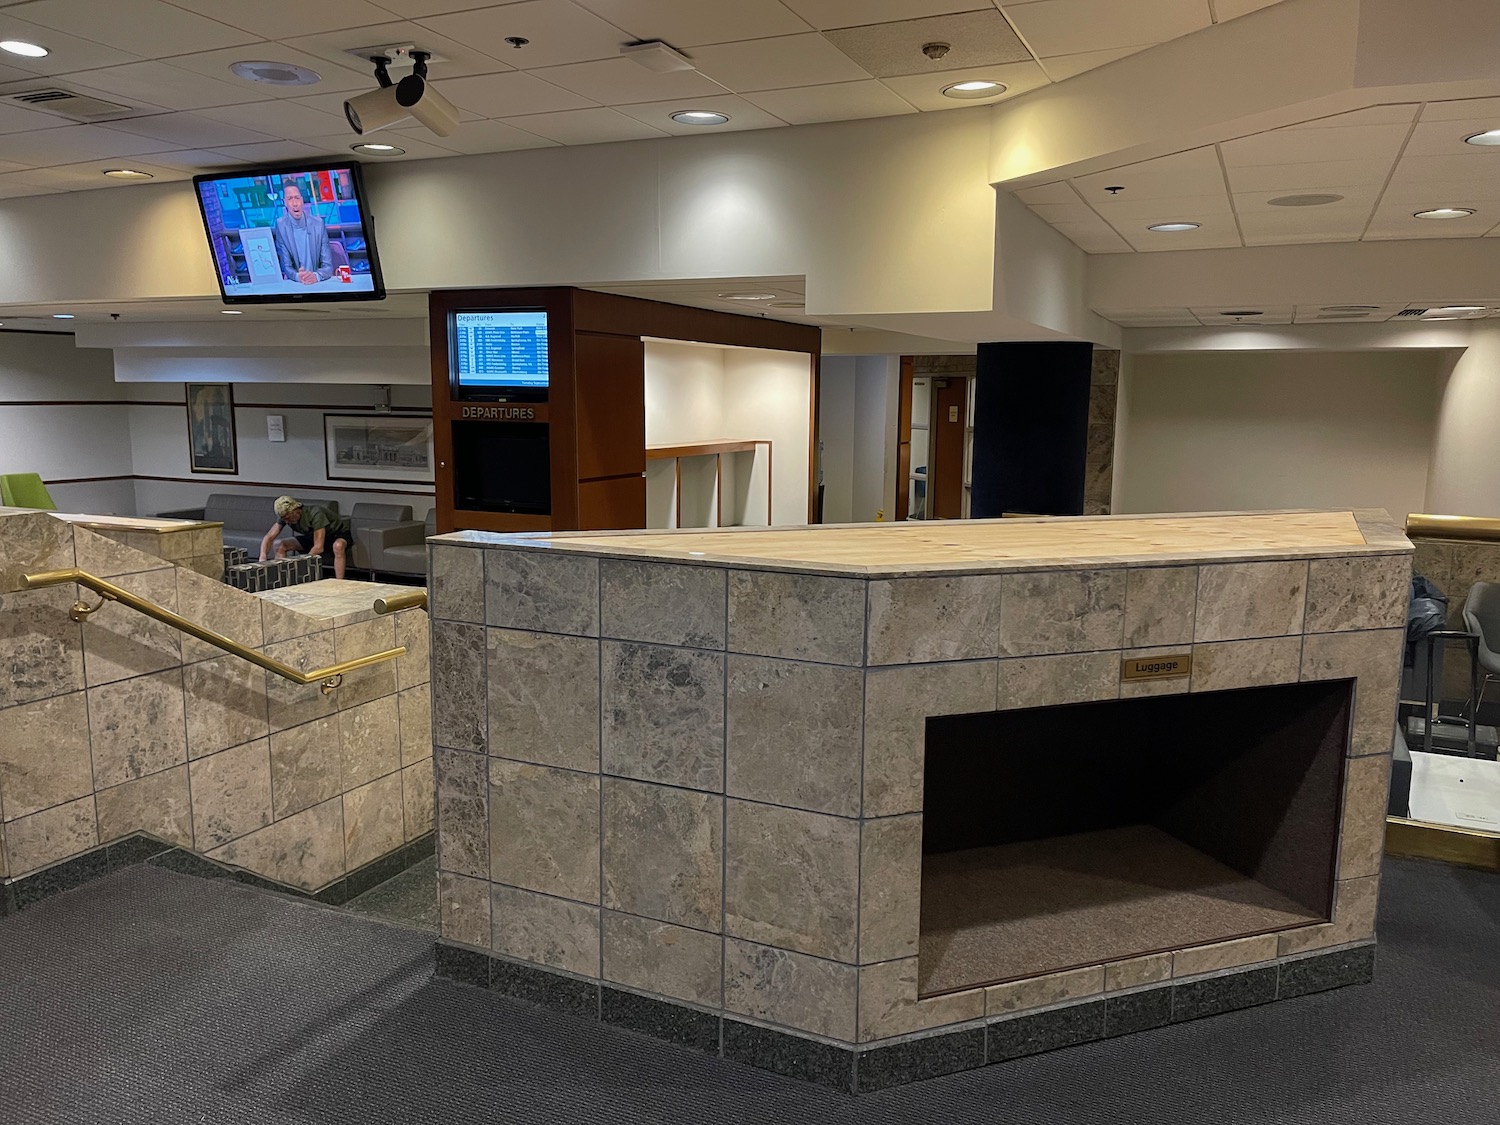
<box><xmin>729</xmin><ymin>570</ymin><xmax>866</xmax><ymax>665</ymax></box>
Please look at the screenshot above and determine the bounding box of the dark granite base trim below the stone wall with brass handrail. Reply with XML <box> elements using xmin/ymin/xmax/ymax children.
<box><xmin>0</xmin><ymin>833</ymin><xmax>437</xmax><ymax>918</ymax></box>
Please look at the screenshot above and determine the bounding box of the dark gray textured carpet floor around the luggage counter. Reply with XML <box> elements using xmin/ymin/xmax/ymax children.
<box><xmin>0</xmin><ymin>861</ymin><xmax>1500</xmax><ymax>1125</ymax></box>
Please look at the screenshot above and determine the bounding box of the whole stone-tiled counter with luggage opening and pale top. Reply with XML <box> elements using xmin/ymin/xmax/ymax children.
<box><xmin>432</xmin><ymin>512</ymin><xmax>1412</xmax><ymax>1091</ymax></box>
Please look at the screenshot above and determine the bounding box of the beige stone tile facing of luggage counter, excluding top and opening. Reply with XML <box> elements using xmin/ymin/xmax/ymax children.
<box><xmin>431</xmin><ymin>513</ymin><xmax>1410</xmax><ymax>1092</ymax></box>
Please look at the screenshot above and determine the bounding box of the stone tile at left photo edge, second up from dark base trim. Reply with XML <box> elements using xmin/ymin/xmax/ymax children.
<box><xmin>0</xmin><ymin>692</ymin><xmax>95</xmax><ymax>821</ymax></box>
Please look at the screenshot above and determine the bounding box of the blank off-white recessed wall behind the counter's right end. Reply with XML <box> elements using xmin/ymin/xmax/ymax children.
<box><xmin>1115</xmin><ymin>351</ymin><xmax>1446</xmax><ymax>519</ymax></box>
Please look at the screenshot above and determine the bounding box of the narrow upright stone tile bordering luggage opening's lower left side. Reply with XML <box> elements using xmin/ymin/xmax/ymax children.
<box><xmin>860</xmin><ymin>815</ymin><xmax>923</xmax><ymax>965</ymax></box>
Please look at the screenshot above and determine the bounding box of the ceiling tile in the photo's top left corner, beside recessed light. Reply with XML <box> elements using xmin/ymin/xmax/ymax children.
<box><xmin>6</xmin><ymin>0</ymin><xmax>257</xmax><ymax>59</ymax></box>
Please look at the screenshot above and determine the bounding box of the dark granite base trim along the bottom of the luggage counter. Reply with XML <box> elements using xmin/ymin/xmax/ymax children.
<box><xmin>435</xmin><ymin>941</ymin><xmax>1376</xmax><ymax>1094</ymax></box>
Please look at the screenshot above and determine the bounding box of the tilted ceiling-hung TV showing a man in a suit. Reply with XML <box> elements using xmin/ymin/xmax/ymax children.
<box><xmin>194</xmin><ymin>162</ymin><xmax>386</xmax><ymax>305</ymax></box>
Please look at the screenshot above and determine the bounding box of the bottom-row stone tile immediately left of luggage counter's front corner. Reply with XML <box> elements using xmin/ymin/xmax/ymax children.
<box><xmin>725</xmin><ymin>938</ymin><xmax>860</xmax><ymax>1043</ymax></box>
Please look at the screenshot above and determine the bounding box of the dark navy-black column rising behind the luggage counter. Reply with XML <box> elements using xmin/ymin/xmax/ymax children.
<box><xmin>969</xmin><ymin>342</ymin><xmax>1094</xmax><ymax>519</ymax></box>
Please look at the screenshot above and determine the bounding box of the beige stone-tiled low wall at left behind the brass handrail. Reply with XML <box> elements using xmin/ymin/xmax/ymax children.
<box><xmin>0</xmin><ymin>510</ymin><xmax>432</xmax><ymax>893</ymax></box>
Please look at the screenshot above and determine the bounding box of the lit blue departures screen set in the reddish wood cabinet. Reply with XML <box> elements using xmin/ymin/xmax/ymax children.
<box><xmin>449</xmin><ymin>309</ymin><xmax>551</xmax><ymax>399</ymax></box>
